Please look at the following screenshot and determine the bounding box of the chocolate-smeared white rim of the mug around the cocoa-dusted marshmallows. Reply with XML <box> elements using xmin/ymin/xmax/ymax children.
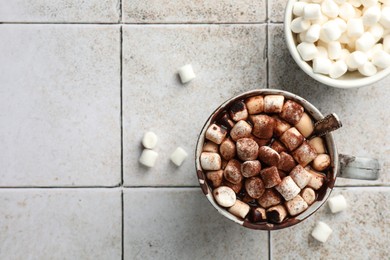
<box><xmin>195</xmin><ymin>89</ymin><xmax>339</xmax><ymax>230</ymax></box>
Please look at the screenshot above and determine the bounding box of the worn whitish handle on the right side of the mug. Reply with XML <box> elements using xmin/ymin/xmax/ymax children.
<box><xmin>337</xmin><ymin>154</ymin><xmax>380</xmax><ymax>180</ymax></box>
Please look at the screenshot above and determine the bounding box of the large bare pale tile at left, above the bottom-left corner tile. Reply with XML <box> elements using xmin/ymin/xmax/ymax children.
<box><xmin>0</xmin><ymin>24</ymin><xmax>121</xmax><ymax>186</ymax></box>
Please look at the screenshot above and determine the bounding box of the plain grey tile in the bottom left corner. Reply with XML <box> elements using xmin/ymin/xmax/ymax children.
<box><xmin>0</xmin><ymin>189</ymin><xmax>122</xmax><ymax>259</ymax></box>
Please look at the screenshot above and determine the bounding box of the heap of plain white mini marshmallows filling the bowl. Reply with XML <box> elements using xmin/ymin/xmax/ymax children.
<box><xmin>290</xmin><ymin>0</ymin><xmax>390</xmax><ymax>79</ymax></box>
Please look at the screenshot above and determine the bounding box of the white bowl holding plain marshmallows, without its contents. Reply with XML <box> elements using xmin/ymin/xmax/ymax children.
<box><xmin>284</xmin><ymin>0</ymin><xmax>390</xmax><ymax>88</ymax></box>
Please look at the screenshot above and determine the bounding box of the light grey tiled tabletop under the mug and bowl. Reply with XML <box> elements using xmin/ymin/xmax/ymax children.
<box><xmin>0</xmin><ymin>0</ymin><xmax>390</xmax><ymax>259</ymax></box>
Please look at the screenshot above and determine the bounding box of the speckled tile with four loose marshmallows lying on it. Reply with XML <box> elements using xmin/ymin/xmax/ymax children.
<box><xmin>123</xmin><ymin>25</ymin><xmax>266</xmax><ymax>186</ymax></box>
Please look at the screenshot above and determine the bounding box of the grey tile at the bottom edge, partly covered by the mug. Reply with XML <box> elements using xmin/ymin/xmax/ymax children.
<box><xmin>124</xmin><ymin>188</ymin><xmax>268</xmax><ymax>259</ymax></box>
